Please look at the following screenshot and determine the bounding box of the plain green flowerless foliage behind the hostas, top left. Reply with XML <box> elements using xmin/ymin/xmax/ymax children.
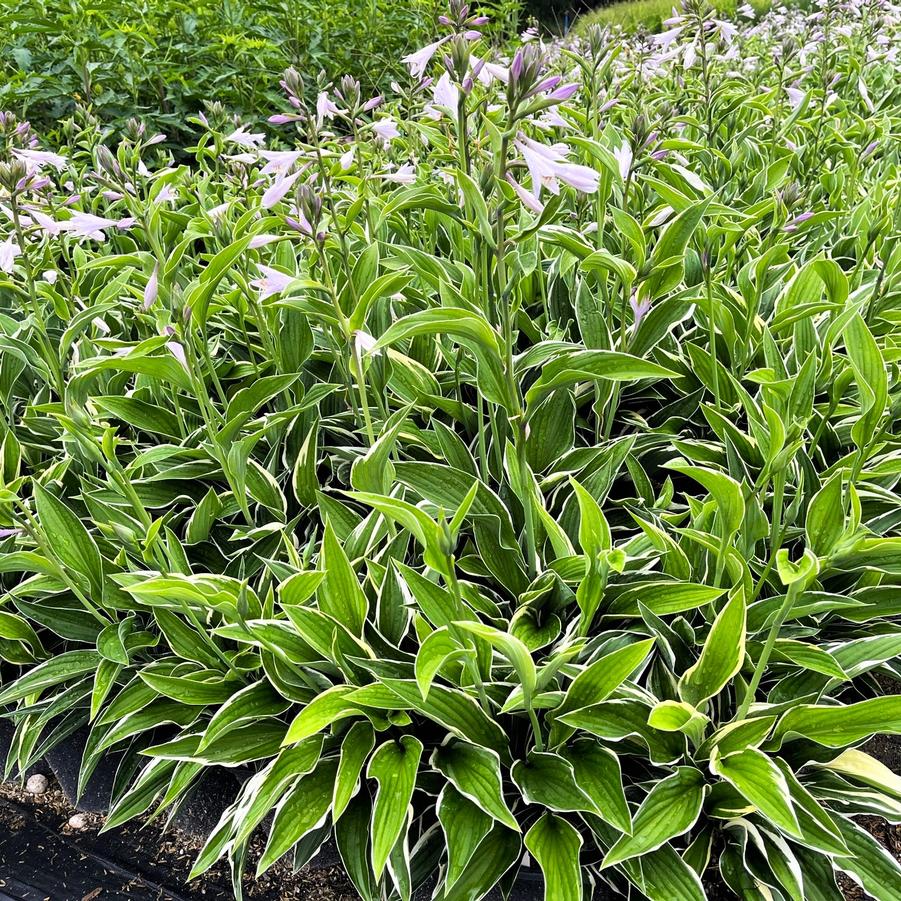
<box><xmin>0</xmin><ymin>0</ymin><xmax>435</xmax><ymax>137</ymax></box>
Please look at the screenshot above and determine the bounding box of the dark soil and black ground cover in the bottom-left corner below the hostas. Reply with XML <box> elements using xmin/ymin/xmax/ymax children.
<box><xmin>0</xmin><ymin>780</ymin><xmax>357</xmax><ymax>901</ymax></box>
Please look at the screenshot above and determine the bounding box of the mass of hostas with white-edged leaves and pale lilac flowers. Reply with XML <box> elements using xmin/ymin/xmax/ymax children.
<box><xmin>0</xmin><ymin>3</ymin><xmax>901</xmax><ymax>901</ymax></box>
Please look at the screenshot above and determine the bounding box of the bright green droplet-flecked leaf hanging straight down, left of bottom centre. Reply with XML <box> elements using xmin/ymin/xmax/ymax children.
<box><xmin>366</xmin><ymin>735</ymin><xmax>422</xmax><ymax>879</ymax></box>
